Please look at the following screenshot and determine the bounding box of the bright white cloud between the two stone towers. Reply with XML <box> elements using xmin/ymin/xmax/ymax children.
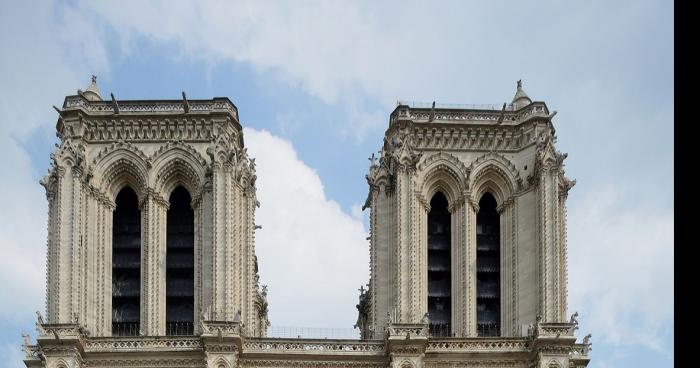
<box><xmin>244</xmin><ymin>128</ymin><xmax>369</xmax><ymax>328</ymax></box>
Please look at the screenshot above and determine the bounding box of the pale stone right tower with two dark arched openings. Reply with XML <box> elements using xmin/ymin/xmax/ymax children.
<box><xmin>365</xmin><ymin>81</ymin><xmax>574</xmax><ymax>337</ymax></box>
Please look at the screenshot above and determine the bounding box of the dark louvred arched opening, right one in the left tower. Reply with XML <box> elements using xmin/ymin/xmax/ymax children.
<box><xmin>165</xmin><ymin>186</ymin><xmax>194</xmax><ymax>335</ymax></box>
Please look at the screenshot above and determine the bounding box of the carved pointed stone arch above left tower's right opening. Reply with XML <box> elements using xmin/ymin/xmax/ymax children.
<box><xmin>149</xmin><ymin>142</ymin><xmax>206</xmax><ymax>198</ymax></box>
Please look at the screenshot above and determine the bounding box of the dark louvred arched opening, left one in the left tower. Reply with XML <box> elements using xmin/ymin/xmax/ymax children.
<box><xmin>112</xmin><ymin>187</ymin><xmax>141</xmax><ymax>336</ymax></box>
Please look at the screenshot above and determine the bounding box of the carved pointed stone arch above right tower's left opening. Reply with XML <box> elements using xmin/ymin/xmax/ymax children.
<box><xmin>418</xmin><ymin>152</ymin><xmax>469</xmax><ymax>207</ymax></box>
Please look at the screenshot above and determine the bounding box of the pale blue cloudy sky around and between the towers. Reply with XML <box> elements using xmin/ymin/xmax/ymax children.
<box><xmin>0</xmin><ymin>0</ymin><xmax>674</xmax><ymax>368</ymax></box>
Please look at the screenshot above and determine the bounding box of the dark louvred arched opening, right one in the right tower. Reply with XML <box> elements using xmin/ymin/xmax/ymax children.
<box><xmin>476</xmin><ymin>193</ymin><xmax>501</xmax><ymax>336</ymax></box>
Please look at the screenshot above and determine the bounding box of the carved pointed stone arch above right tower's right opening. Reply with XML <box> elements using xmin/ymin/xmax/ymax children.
<box><xmin>469</xmin><ymin>152</ymin><xmax>522</xmax><ymax>206</ymax></box>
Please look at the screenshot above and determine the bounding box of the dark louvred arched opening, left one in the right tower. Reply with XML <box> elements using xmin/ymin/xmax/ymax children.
<box><xmin>428</xmin><ymin>192</ymin><xmax>452</xmax><ymax>336</ymax></box>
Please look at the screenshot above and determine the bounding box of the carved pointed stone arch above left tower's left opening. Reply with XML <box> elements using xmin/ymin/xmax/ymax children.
<box><xmin>93</xmin><ymin>142</ymin><xmax>150</xmax><ymax>201</ymax></box>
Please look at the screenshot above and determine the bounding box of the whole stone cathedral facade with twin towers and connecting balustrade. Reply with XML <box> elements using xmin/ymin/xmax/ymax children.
<box><xmin>24</xmin><ymin>77</ymin><xmax>590</xmax><ymax>368</ymax></box>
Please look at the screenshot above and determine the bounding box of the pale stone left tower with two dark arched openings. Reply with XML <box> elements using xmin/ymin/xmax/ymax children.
<box><xmin>23</xmin><ymin>77</ymin><xmax>268</xmax><ymax>364</ymax></box>
